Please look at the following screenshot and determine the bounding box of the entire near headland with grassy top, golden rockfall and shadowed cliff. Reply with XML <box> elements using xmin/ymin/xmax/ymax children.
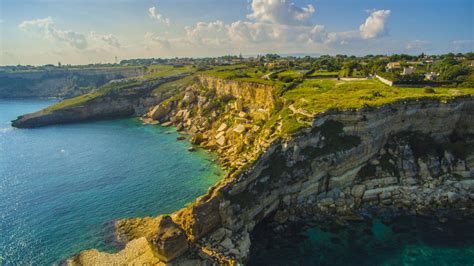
<box><xmin>33</xmin><ymin>65</ymin><xmax>474</xmax><ymax>265</ymax></box>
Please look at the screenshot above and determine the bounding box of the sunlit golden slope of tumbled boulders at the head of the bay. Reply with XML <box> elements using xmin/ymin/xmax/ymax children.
<box><xmin>147</xmin><ymin>76</ymin><xmax>276</xmax><ymax>170</ymax></box>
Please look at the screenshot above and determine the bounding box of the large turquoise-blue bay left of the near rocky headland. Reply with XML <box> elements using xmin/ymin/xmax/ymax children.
<box><xmin>0</xmin><ymin>100</ymin><xmax>220</xmax><ymax>265</ymax></box>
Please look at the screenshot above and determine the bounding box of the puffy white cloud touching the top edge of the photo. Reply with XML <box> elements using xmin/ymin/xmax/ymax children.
<box><xmin>247</xmin><ymin>0</ymin><xmax>315</xmax><ymax>25</ymax></box>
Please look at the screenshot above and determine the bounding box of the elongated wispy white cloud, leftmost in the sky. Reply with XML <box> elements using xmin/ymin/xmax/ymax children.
<box><xmin>19</xmin><ymin>17</ymin><xmax>87</xmax><ymax>50</ymax></box>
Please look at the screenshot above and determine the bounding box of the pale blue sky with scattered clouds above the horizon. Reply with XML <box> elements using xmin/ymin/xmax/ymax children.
<box><xmin>0</xmin><ymin>0</ymin><xmax>474</xmax><ymax>65</ymax></box>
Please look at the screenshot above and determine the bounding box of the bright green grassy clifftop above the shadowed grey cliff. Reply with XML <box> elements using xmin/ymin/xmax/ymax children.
<box><xmin>266</xmin><ymin>79</ymin><xmax>474</xmax><ymax>134</ymax></box>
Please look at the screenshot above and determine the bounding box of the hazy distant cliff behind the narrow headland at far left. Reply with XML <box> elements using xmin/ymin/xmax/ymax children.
<box><xmin>0</xmin><ymin>67</ymin><xmax>144</xmax><ymax>98</ymax></box>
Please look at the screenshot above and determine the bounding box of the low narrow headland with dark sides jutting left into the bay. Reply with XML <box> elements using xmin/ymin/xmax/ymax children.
<box><xmin>12</xmin><ymin>75</ymin><xmax>183</xmax><ymax>128</ymax></box>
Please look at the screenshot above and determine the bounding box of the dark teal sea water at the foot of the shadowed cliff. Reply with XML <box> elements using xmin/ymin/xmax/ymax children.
<box><xmin>249</xmin><ymin>216</ymin><xmax>474</xmax><ymax>266</ymax></box>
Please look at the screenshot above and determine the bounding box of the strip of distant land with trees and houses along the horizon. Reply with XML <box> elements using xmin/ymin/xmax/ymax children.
<box><xmin>0</xmin><ymin>52</ymin><xmax>474</xmax><ymax>87</ymax></box>
